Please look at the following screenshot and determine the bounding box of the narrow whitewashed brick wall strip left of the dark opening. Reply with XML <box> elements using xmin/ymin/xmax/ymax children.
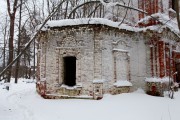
<box><xmin>43</xmin><ymin>31</ymin><xmax>59</xmax><ymax>94</ymax></box>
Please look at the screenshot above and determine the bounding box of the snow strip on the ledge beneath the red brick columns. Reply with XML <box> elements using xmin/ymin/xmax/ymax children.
<box><xmin>145</xmin><ymin>77</ymin><xmax>171</xmax><ymax>83</ymax></box>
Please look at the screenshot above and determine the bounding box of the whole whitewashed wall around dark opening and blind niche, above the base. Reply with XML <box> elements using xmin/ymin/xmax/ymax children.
<box><xmin>40</xmin><ymin>25</ymin><xmax>149</xmax><ymax>95</ymax></box>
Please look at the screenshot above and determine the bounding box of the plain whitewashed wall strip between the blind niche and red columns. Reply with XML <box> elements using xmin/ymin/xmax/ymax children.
<box><xmin>130</xmin><ymin>34</ymin><xmax>148</xmax><ymax>90</ymax></box>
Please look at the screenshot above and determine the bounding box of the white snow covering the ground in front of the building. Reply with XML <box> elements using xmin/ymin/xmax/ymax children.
<box><xmin>0</xmin><ymin>79</ymin><xmax>180</xmax><ymax>120</ymax></box>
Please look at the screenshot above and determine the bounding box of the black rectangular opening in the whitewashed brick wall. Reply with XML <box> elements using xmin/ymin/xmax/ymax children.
<box><xmin>64</xmin><ymin>56</ymin><xmax>76</xmax><ymax>86</ymax></box>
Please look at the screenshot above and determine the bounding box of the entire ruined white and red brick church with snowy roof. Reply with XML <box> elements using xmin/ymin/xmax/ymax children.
<box><xmin>37</xmin><ymin>0</ymin><xmax>180</xmax><ymax>99</ymax></box>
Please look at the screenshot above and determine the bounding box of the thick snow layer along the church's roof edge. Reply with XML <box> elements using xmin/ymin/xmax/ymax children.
<box><xmin>41</xmin><ymin>13</ymin><xmax>180</xmax><ymax>37</ymax></box>
